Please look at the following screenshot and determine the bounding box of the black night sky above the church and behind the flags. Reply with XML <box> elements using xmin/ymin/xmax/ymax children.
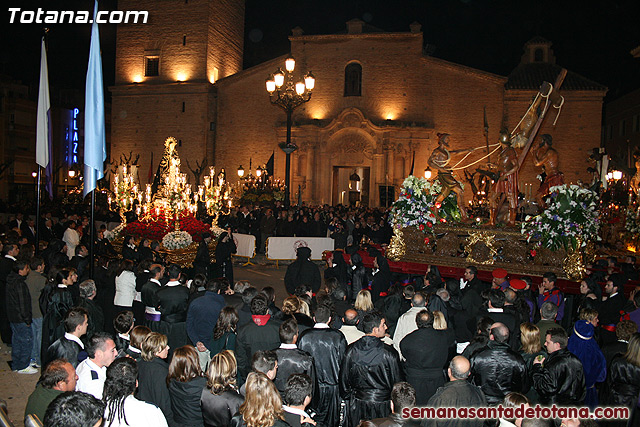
<box><xmin>0</xmin><ymin>0</ymin><xmax>640</xmax><ymax>100</ymax></box>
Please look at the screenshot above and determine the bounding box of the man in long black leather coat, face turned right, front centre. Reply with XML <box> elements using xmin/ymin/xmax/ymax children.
<box><xmin>340</xmin><ymin>311</ymin><xmax>402</xmax><ymax>427</ymax></box>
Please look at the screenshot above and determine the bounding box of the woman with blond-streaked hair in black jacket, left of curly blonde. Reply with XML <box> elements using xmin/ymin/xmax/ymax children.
<box><xmin>200</xmin><ymin>350</ymin><xmax>244</xmax><ymax>427</ymax></box>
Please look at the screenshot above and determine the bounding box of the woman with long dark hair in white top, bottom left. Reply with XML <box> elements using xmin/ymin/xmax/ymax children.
<box><xmin>102</xmin><ymin>357</ymin><xmax>167</xmax><ymax>427</ymax></box>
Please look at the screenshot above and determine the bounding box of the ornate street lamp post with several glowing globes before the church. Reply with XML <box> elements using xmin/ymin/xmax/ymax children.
<box><xmin>266</xmin><ymin>56</ymin><xmax>315</xmax><ymax>207</ymax></box>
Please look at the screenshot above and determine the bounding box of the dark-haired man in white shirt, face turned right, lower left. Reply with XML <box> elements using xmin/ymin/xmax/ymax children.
<box><xmin>76</xmin><ymin>332</ymin><xmax>118</xmax><ymax>399</ymax></box>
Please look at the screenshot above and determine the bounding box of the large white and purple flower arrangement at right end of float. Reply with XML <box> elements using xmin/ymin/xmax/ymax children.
<box><xmin>521</xmin><ymin>184</ymin><xmax>600</xmax><ymax>250</ymax></box>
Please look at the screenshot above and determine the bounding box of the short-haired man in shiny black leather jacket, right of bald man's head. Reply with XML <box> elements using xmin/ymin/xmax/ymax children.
<box><xmin>471</xmin><ymin>323</ymin><xmax>530</xmax><ymax>405</ymax></box>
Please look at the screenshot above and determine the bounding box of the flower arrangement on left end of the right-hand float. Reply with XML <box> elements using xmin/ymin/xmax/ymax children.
<box><xmin>389</xmin><ymin>175</ymin><xmax>460</xmax><ymax>231</ymax></box>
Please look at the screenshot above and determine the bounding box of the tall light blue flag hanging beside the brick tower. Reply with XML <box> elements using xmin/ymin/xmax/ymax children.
<box><xmin>84</xmin><ymin>0</ymin><xmax>107</xmax><ymax>196</ymax></box>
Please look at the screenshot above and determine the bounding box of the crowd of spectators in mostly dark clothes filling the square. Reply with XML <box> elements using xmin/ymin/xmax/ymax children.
<box><xmin>0</xmin><ymin>207</ymin><xmax>640</xmax><ymax>427</ymax></box>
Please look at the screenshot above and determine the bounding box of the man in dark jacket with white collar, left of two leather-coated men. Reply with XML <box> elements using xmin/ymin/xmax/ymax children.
<box><xmin>273</xmin><ymin>318</ymin><xmax>316</xmax><ymax>394</ymax></box>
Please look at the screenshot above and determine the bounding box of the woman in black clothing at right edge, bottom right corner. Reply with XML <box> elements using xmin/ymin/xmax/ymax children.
<box><xmin>601</xmin><ymin>332</ymin><xmax>640</xmax><ymax>426</ymax></box>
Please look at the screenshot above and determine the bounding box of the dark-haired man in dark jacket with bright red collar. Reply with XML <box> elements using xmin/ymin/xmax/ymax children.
<box><xmin>236</xmin><ymin>294</ymin><xmax>280</xmax><ymax>379</ymax></box>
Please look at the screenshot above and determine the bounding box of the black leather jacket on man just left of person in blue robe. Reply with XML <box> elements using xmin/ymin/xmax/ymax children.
<box><xmin>532</xmin><ymin>348</ymin><xmax>587</xmax><ymax>405</ymax></box>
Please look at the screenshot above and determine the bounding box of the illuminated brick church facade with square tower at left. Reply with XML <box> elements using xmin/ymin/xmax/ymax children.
<box><xmin>110</xmin><ymin>0</ymin><xmax>606</xmax><ymax>206</ymax></box>
